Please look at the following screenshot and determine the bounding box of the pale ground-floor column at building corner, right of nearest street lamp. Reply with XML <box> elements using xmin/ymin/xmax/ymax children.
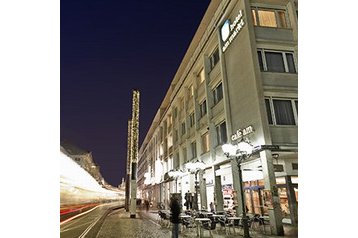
<box><xmin>260</xmin><ymin>150</ymin><xmax>284</xmax><ymax>236</ymax></box>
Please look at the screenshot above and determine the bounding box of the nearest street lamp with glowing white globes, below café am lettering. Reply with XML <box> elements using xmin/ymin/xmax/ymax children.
<box><xmin>221</xmin><ymin>140</ymin><xmax>252</xmax><ymax>238</ymax></box>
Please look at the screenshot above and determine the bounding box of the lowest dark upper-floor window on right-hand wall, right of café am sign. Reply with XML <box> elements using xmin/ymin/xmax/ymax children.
<box><xmin>265</xmin><ymin>98</ymin><xmax>298</xmax><ymax>125</ymax></box>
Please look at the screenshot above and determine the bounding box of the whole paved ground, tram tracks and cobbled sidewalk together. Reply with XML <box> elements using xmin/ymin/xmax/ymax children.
<box><xmin>61</xmin><ymin>203</ymin><xmax>298</xmax><ymax>238</ymax></box>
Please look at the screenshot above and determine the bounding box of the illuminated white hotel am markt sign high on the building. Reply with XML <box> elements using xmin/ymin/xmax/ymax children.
<box><xmin>221</xmin><ymin>10</ymin><xmax>245</xmax><ymax>53</ymax></box>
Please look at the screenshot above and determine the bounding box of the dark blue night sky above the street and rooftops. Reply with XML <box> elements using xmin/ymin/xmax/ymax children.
<box><xmin>60</xmin><ymin>0</ymin><xmax>210</xmax><ymax>186</ymax></box>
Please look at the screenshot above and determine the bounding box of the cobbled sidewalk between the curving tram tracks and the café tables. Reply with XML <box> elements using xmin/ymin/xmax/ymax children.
<box><xmin>96</xmin><ymin>209</ymin><xmax>298</xmax><ymax>238</ymax></box>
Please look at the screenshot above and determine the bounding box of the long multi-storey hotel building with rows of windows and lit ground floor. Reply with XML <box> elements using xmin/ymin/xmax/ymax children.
<box><xmin>137</xmin><ymin>0</ymin><xmax>298</xmax><ymax>235</ymax></box>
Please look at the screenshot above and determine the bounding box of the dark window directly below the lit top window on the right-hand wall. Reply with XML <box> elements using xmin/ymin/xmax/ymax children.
<box><xmin>257</xmin><ymin>49</ymin><xmax>296</xmax><ymax>73</ymax></box>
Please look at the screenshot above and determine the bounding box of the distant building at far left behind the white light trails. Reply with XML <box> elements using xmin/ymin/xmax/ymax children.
<box><xmin>61</xmin><ymin>140</ymin><xmax>106</xmax><ymax>185</ymax></box>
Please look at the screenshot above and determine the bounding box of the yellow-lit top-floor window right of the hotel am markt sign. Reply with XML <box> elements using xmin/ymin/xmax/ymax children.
<box><xmin>251</xmin><ymin>7</ymin><xmax>289</xmax><ymax>28</ymax></box>
